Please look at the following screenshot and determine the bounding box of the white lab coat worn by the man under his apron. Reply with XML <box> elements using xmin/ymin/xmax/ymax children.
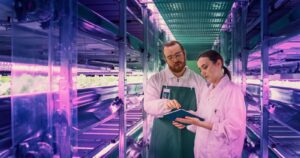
<box><xmin>144</xmin><ymin>66</ymin><xmax>207</xmax><ymax>143</ymax></box>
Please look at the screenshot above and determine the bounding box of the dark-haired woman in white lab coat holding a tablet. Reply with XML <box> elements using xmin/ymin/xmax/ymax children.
<box><xmin>173</xmin><ymin>50</ymin><xmax>246</xmax><ymax>158</ymax></box>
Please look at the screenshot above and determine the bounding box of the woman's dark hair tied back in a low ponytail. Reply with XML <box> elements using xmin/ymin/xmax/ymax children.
<box><xmin>198</xmin><ymin>50</ymin><xmax>231</xmax><ymax>80</ymax></box>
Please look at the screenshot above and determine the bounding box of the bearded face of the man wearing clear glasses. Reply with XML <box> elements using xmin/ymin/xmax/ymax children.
<box><xmin>164</xmin><ymin>44</ymin><xmax>186</xmax><ymax>73</ymax></box>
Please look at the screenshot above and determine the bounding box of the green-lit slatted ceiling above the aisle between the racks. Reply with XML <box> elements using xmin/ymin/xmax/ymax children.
<box><xmin>155</xmin><ymin>0</ymin><xmax>234</xmax><ymax>57</ymax></box>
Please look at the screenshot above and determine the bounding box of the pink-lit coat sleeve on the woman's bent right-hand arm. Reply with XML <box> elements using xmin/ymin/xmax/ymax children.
<box><xmin>212</xmin><ymin>87</ymin><xmax>246</xmax><ymax>143</ymax></box>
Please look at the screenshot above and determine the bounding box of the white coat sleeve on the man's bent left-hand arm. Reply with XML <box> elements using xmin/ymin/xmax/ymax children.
<box><xmin>144</xmin><ymin>77</ymin><xmax>171</xmax><ymax>117</ymax></box>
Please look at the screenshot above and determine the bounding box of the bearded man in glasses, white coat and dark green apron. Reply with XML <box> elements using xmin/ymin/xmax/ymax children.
<box><xmin>144</xmin><ymin>41</ymin><xmax>206</xmax><ymax>158</ymax></box>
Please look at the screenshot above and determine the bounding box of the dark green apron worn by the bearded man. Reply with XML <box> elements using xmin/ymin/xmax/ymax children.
<box><xmin>149</xmin><ymin>86</ymin><xmax>197</xmax><ymax>158</ymax></box>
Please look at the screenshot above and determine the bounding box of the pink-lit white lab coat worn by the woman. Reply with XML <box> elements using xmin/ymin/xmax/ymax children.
<box><xmin>188</xmin><ymin>75</ymin><xmax>246</xmax><ymax>158</ymax></box>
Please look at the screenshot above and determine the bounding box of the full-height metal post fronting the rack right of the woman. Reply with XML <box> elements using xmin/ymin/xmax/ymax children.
<box><xmin>260</xmin><ymin>0</ymin><xmax>269</xmax><ymax>158</ymax></box>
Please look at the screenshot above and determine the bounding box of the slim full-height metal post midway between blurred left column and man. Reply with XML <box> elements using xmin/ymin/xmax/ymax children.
<box><xmin>118</xmin><ymin>0</ymin><xmax>127</xmax><ymax>158</ymax></box>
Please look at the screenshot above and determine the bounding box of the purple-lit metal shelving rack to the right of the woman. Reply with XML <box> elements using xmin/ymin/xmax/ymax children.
<box><xmin>221</xmin><ymin>0</ymin><xmax>300</xmax><ymax>157</ymax></box>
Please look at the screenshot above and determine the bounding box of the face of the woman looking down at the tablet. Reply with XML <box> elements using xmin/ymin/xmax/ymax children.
<box><xmin>197</xmin><ymin>57</ymin><xmax>222</xmax><ymax>84</ymax></box>
